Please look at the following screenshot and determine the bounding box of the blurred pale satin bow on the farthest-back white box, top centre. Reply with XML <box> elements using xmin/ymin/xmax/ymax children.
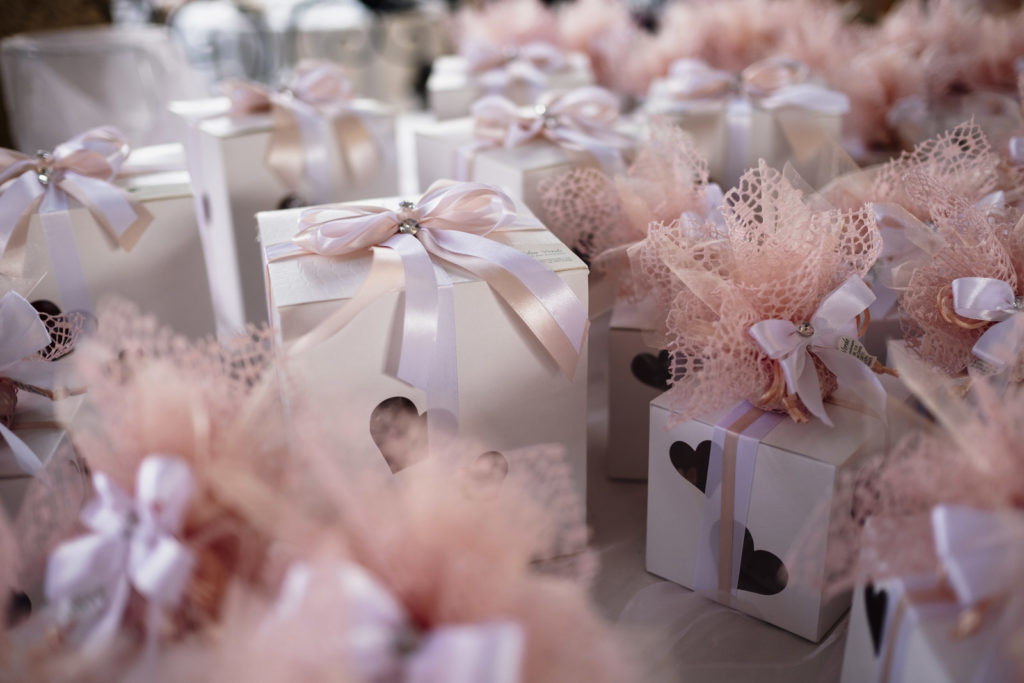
<box><xmin>464</xmin><ymin>41</ymin><xmax>568</xmax><ymax>94</ymax></box>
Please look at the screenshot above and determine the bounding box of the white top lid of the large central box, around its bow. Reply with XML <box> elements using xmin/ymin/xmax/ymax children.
<box><xmin>256</xmin><ymin>197</ymin><xmax>587</xmax><ymax>307</ymax></box>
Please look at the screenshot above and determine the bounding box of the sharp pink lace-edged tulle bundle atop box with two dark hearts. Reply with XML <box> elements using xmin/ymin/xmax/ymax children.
<box><xmin>630</xmin><ymin>162</ymin><xmax>882</xmax><ymax>420</ymax></box>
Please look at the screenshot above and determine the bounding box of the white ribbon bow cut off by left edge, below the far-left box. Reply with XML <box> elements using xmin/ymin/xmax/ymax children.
<box><xmin>0</xmin><ymin>292</ymin><xmax>50</xmax><ymax>476</ymax></box>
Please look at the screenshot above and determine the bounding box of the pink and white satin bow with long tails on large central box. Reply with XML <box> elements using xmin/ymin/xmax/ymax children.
<box><xmin>266</xmin><ymin>181</ymin><xmax>588</xmax><ymax>438</ymax></box>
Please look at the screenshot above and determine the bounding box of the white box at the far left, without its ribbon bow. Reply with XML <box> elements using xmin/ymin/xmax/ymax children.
<box><xmin>15</xmin><ymin>163</ymin><xmax>214</xmax><ymax>337</ymax></box>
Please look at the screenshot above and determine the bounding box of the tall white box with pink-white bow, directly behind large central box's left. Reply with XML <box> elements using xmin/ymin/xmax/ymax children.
<box><xmin>175</xmin><ymin>62</ymin><xmax>398</xmax><ymax>335</ymax></box>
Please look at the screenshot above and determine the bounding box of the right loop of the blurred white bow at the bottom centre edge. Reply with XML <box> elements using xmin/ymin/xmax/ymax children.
<box><xmin>403</xmin><ymin>622</ymin><xmax>525</xmax><ymax>683</ymax></box>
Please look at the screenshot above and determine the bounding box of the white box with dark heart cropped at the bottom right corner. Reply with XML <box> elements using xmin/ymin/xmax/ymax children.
<box><xmin>841</xmin><ymin>574</ymin><xmax>1010</xmax><ymax>683</ymax></box>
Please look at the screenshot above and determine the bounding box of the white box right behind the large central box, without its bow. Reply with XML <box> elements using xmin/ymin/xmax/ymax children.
<box><xmin>415</xmin><ymin>118</ymin><xmax>626</xmax><ymax>220</ymax></box>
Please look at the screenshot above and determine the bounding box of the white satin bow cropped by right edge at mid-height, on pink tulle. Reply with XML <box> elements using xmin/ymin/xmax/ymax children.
<box><xmin>952</xmin><ymin>278</ymin><xmax>1024</xmax><ymax>372</ymax></box>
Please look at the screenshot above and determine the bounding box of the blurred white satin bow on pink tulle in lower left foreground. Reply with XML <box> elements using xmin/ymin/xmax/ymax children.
<box><xmin>44</xmin><ymin>455</ymin><xmax>195</xmax><ymax>652</ymax></box>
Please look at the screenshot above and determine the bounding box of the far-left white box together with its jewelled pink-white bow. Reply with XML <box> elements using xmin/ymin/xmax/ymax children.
<box><xmin>0</xmin><ymin>128</ymin><xmax>214</xmax><ymax>336</ymax></box>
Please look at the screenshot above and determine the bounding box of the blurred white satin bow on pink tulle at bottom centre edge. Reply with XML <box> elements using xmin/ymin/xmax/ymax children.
<box><xmin>274</xmin><ymin>562</ymin><xmax>525</xmax><ymax>683</ymax></box>
